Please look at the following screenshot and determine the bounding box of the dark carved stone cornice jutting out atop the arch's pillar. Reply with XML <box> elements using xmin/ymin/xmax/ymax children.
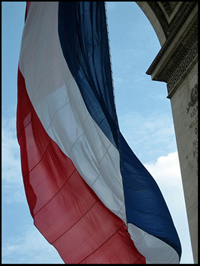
<box><xmin>146</xmin><ymin>2</ymin><xmax>198</xmax><ymax>97</ymax></box>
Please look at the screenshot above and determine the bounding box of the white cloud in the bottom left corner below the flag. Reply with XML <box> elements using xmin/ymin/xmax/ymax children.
<box><xmin>2</xmin><ymin>227</ymin><xmax>64</xmax><ymax>264</ymax></box>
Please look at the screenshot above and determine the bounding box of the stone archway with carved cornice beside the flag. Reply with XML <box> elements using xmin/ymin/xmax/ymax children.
<box><xmin>136</xmin><ymin>1</ymin><xmax>198</xmax><ymax>263</ymax></box>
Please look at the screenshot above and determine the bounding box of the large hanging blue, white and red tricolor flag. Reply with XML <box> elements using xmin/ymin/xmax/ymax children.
<box><xmin>17</xmin><ymin>1</ymin><xmax>181</xmax><ymax>264</ymax></box>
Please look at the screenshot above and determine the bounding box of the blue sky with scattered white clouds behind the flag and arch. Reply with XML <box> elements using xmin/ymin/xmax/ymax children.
<box><xmin>2</xmin><ymin>2</ymin><xmax>193</xmax><ymax>264</ymax></box>
